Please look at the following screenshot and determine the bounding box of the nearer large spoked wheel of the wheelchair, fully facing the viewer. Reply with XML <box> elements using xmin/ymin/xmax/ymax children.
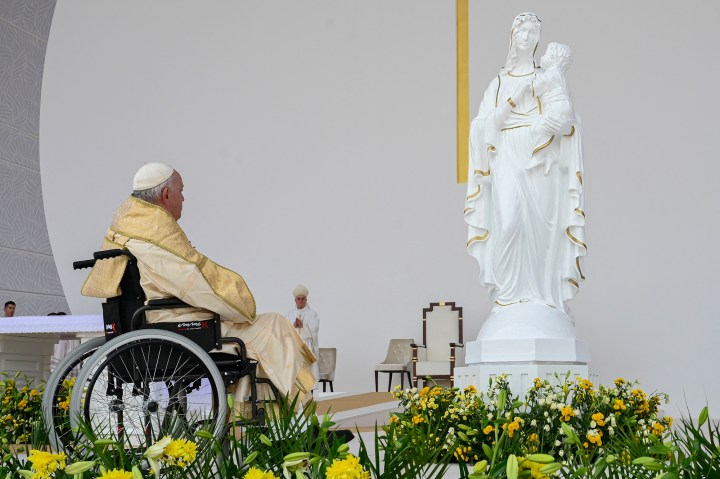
<box><xmin>70</xmin><ymin>329</ymin><xmax>228</xmax><ymax>454</ymax></box>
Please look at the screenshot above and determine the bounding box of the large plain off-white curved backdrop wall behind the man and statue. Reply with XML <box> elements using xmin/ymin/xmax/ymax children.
<box><xmin>40</xmin><ymin>0</ymin><xmax>720</xmax><ymax>414</ymax></box>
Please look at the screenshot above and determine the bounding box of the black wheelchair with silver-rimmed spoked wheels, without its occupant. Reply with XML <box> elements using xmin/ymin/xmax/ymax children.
<box><xmin>43</xmin><ymin>249</ymin><xmax>279</xmax><ymax>456</ymax></box>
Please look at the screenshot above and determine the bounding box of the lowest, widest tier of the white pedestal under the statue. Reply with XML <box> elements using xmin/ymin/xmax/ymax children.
<box><xmin>455</xmin><ymin>362</ymin><xmax>590</xmax><ymax>399</ymax></box>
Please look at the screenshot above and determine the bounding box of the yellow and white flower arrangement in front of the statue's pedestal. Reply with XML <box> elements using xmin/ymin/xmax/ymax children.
<box><xmin>386</xmin><ymin>375</ymin><xmax>672</xmax><ymax>477</ymax></box>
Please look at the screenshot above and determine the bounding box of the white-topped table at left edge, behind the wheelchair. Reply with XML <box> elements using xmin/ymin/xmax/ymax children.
<box><xmin>0</xmin><ymin>314</ymin><xmax>103</xmax><ymax>379</ymax></box>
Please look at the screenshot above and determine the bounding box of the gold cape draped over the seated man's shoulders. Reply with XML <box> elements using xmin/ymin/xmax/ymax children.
<box><xmin>81</xmin><ymin>196</ymin><xmax>256</xmax><ymax>322</ymax></box>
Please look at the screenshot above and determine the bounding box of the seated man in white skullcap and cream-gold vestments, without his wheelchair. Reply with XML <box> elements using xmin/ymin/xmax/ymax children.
<box><xmin>82</xmin><ymin>163</ymin><xmax>316</xmax><ymax>412</ymax></box>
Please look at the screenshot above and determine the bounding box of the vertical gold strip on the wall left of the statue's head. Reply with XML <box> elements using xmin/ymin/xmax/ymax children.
<box><xmin>455</xmin><ymin>0</ymin><xmax>470</xmax><ymax>183</ymax></box>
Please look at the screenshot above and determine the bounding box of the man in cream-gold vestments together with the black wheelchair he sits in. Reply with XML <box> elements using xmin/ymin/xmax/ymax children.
<box><xmin>43</xmin><ymin>163</ymin><xmax>316</xmax><ymax>447</ymax></box>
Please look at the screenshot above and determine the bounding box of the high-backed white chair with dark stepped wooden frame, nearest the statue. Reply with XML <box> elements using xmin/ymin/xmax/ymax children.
<box><xmin>412</xmin><ymin>302</ymin><xmax>465</xmax><ymax>387</ymax></box>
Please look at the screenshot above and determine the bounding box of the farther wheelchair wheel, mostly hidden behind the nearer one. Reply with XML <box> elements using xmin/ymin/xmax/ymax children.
<box><xmin>42</xmin><ymin>337</ymin><xmax>105</xmax><ymax>451</ymax></box>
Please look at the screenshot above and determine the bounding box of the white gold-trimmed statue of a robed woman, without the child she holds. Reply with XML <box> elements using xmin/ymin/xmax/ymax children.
<box><xmin>465</xmin><ymin>13</ymin><xmax>586</xmax><ymax>333</ymax></box>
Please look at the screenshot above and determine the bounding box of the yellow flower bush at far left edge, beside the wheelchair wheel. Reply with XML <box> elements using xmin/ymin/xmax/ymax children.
<box><xmin>0</xmin><ymin>373</ymin><xmax>43</xmax><ymax>444</ymax></box>
